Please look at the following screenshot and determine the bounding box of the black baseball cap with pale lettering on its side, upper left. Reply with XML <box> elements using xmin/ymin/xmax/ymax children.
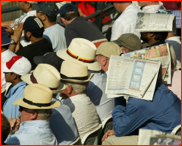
<box><xmin>23</xmin><ymin>16</ymin><xmax>44</xmax><ymax>32</ymax></box>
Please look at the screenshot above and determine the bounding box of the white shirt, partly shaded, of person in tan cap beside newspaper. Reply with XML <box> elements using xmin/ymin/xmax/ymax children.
<box><xmin>87</xmin><ymin>73</ymin><xmax>114</xmax><ymax>122</ymax></box>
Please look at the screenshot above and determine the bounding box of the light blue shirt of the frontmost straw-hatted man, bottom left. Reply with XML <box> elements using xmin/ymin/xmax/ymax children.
<box><xmin>5</xmin><ymin>120</ymin><xmax>57</xmax><ymax>145</ymax></box>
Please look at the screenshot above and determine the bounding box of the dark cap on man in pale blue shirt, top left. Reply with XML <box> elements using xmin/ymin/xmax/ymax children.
<box><xmin>32</xmin><ymin>1</ymin><xmax>59</xmax><ymax>17</ymax></box>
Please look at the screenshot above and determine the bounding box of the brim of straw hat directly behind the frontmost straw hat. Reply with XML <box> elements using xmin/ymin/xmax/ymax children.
<box><xmin>21</xmin><ymin>74</ymin><xmax>65</xmax><ymax>94</ymax></box>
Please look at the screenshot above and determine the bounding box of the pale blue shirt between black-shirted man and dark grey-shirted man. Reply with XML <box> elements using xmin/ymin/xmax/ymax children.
<box><xmin>43</xmin><ymin>24</ymin><xmax>67</xmax><ymax>52</ymax></box>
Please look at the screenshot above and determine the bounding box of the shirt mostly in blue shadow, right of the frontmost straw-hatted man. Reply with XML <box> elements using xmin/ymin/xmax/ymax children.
<box><xmin>49</xmin><ymin>98</ymin><xmax>78</xmax><ymax>145</ymax></box>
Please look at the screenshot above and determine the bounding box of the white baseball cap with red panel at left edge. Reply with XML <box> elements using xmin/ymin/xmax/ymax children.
<box><xmin>2</xmin><ymin>56</ymin><xmax>32</xmax><ymax>76</ymax></box>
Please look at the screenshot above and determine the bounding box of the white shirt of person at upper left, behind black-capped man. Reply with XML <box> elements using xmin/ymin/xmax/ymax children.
<box><xmin>10</xmin><ymin>10</ymin><xmax>36</xmax><ymax>47</ymax></box>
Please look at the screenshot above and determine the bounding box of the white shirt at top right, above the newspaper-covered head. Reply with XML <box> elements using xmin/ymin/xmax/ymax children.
<box><xmin>142</xmin><ymin>1</ymin><xmax>165</xmax><ymax>13</ymax></box>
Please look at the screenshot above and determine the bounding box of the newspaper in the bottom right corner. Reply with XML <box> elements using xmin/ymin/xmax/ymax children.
<box><xmin>138</xmin><ymin>129</ymin><xmax>181</xmax><ymax>145</ymax></box>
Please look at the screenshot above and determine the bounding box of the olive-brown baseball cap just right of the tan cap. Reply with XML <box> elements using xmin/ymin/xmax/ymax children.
<box><xmin>112</xmin><ymin>33</ymin><xmax>142</xmax><ymax>51</ymax></box>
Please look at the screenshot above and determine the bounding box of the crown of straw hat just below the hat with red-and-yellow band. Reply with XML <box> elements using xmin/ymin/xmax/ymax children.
<box><xmin>61</xmin><ymin>60</ymin><xmax>88</xmax><ymax>78</ymax></box>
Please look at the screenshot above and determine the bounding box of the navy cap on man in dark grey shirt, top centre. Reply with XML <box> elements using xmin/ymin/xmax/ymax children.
<box><xmin>59</xmin><ymin>4</ymin><xmax>78</xmax><ymax>16</ymax></box>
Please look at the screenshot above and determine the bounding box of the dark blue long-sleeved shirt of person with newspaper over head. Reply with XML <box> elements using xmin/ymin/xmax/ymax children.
<box><xmin>112</xmin><ymin>83</ymin><xmax>181</xmax><ymax>136</ymax></box>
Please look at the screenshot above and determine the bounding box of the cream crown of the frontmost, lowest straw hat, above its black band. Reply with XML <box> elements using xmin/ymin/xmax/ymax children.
<box><xmin>24</xmin><ymin>84</ymin><xmax>52</xmax><ymax>104</ymax></box>
